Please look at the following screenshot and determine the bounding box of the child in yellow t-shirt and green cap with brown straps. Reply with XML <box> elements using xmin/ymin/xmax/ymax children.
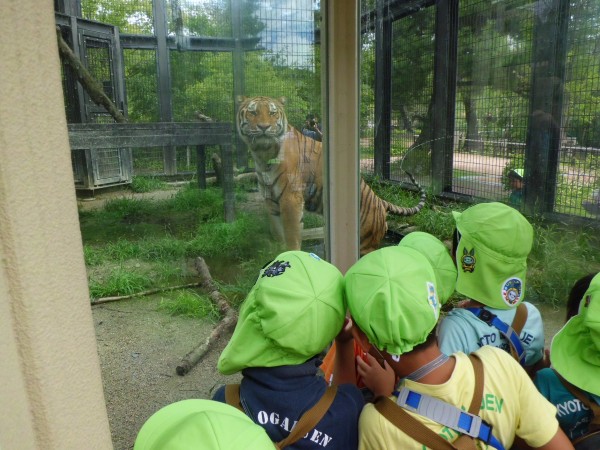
<box><xmin>345</xmin><ymin>247</ymin><xmax>573</xmax><ymax>450</ymax></box>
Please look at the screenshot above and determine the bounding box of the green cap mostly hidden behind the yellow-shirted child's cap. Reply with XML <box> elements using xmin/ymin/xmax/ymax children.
<box><xmin>398</xmin><ymin>231</ymin><xmax>456</xmax><ymax>305</ymax></box>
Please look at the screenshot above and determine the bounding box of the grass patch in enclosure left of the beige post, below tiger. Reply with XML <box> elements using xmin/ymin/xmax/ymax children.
<box><xmin>80</xmin><ymin>184</ymin><xmax>279</xmax><ymax>304</ymax></box>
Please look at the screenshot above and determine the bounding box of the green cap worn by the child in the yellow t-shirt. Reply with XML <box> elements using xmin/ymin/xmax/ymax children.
<box><xmin>345</xmin><ymin>246</ymin><xmax>440</xmax><ymax>355</ymax></box>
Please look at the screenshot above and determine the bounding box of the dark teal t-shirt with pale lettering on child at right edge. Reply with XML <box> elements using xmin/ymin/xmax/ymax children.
<box><xmin>533</xmin><ymin>368</ymin><xmax>600</xmax><ymax>441</ymax></box>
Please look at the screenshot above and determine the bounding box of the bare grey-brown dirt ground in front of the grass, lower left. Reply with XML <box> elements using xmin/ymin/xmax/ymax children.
<box><xmin>92</xmin><ymin>295</ymin><xmax>239</xmax><ymax>450</ymax></box>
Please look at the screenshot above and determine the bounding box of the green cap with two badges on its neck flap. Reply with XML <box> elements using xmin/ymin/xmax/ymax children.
<box><xmin>452</xmin><ymin>202</ymin><xmax>533</xmax><ymax>309</ymax></box>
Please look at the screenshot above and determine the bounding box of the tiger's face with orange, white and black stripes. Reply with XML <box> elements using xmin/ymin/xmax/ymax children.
<box><xmin>237</xmin><ymin>97</ymin><xmax>288</xmax><ymax>147</ymax></box>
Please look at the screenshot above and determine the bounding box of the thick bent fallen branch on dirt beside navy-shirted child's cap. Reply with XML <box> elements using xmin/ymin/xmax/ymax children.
<box><xmin>176</xmin><ymin>257</ymin><xmax>238</xmax><ymax>376</ymax></box>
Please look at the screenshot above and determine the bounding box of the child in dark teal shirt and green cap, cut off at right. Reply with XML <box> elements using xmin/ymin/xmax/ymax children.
<box><xmin>534</xmin><ymin>274</ymin><xmax>600</xmax><ymax>449</ymax></box>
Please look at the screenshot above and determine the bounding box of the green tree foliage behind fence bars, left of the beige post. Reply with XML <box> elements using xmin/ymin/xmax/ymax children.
<box><xmin>82</xmin><ymin>0</ymin><xmax>322</xmax><ymax>128</ymax></box>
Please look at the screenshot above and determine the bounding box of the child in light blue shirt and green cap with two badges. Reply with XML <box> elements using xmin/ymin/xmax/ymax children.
<box><xmin>438</xmin><ymin>202</ymin><xmax>545</xmax><ymax>375</ymax></box>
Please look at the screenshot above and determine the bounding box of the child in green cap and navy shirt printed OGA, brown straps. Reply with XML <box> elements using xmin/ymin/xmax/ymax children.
<box><xmin>213</xmin><ymin>251</ymin><xmax>364</xmax><ymax>449</ymax></box>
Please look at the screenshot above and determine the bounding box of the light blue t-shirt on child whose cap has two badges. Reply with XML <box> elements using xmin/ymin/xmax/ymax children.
<box><xmin>438</xmin><ymin>302</ymin><xmax>544</xmax><ymax>366</ymax></box>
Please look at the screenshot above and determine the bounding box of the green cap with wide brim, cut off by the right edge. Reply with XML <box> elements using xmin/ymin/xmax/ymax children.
<box><xmin>550</xmin><ymin>274</ymin><xmax>600</xmax><ymax>395</ymax></box>
